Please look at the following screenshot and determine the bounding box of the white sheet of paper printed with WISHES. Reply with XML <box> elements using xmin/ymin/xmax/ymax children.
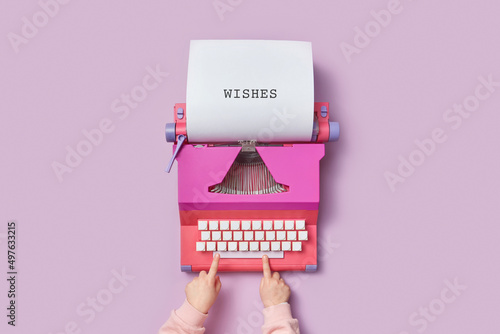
<box><xmin>186</xmin><ymin>40</ymin><xmax>314</xmax><ymax>143</ymax></box>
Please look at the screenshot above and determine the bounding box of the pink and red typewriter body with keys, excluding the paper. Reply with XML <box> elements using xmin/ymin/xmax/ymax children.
<box><xmin>166</xmin><ymin>41</ymin><xmax>339</xmax><ymax>272</ymax></box>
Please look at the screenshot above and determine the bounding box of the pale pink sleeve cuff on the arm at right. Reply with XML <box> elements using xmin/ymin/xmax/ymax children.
<box><xmin>262</xmin><ymin>303</ymin><xmax>300</xmax><ymax>334</ymax></box>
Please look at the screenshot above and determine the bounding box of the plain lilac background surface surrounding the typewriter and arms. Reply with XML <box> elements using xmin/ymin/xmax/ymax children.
<box><xmin>0</xmin><ymin>0</ymin><xmax>500</xmax><ymax>334</ymax></box>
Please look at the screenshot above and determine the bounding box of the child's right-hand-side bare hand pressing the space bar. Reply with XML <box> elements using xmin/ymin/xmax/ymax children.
<box><xmin>260</xmin><ymin>255</ymin><xmax>290</xmax><ymax>307</ymax></box>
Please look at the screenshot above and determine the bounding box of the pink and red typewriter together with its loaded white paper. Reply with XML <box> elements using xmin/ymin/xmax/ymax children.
<box><xmin>166</xmin><ymin>40</ymin><xmax>339</xmax><ymax>272</ymax></box>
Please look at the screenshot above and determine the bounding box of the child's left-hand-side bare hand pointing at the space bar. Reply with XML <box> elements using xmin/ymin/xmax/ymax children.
<box><xmin>186</xmin><ymin>254</ymin><xmax>222</xmax><ymax>313</ymax></box>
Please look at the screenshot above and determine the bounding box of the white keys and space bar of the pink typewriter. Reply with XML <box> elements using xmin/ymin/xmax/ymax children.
<box><xmin>196</xmin><ymin>219</ymin><xmax>308</xmax><ymax>258</ymax></box>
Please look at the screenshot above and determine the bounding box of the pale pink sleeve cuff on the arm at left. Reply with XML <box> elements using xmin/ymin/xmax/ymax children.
<box><xmin>158</xmin><ymin>300</ymin><xmax>208</xmax><ymax>334</ymax></box>
